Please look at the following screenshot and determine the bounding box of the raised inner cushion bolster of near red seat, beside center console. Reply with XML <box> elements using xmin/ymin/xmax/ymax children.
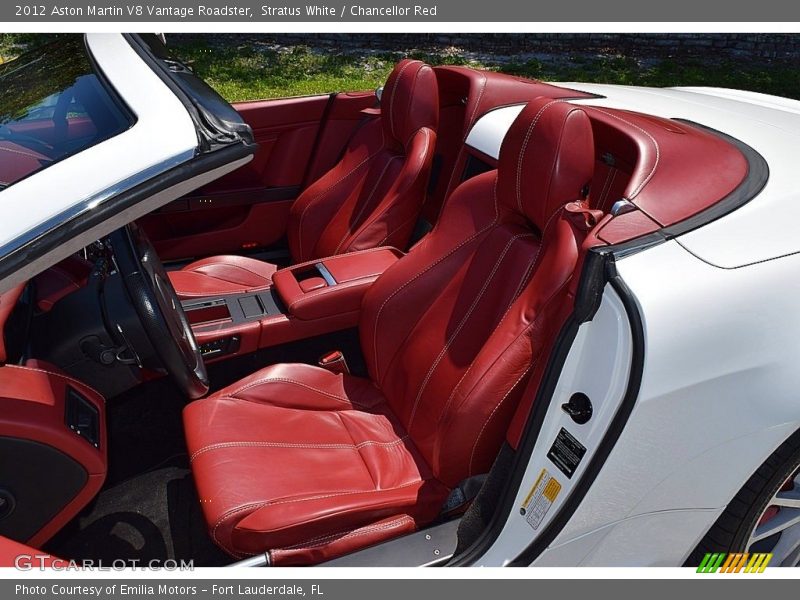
<box><xmin>214</xmin><ymin>363</ymin><xmax>383</xmax><ymax>411</ymax></box>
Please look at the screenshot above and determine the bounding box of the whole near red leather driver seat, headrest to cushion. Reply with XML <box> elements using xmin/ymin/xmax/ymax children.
<box><xmin>184</xmin><ymin>99</ymin><xmax>594</xmax><ymax>565</ymax></box>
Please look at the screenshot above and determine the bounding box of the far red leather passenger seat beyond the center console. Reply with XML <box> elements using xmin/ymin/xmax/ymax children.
<box><xmin>170</xmin><ymin>59</ymin><xmax>439</xmax><ymax>298</ymax></box>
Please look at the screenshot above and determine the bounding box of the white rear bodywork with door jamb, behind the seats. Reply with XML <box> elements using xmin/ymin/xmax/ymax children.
<box><xmin>467</xmin><ymin>83</ymin><xmax>800</xmax><ymax>566</ymax></box>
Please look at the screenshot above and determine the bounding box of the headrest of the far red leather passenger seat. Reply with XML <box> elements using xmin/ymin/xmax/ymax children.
<box><xmin>381</xmin><ymin>59</ymin><xmax>439</xmax><ymax>147</ymax></box>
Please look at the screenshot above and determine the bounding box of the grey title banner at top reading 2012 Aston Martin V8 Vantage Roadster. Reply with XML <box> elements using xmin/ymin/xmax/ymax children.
<box><xmin>0</xmin><ymin>0</ymin><xmax>800</xmax><ymax>23</ymax></box>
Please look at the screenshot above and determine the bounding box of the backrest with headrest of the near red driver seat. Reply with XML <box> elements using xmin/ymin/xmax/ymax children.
<box><xmin>360</xmin><ymin>99</ymin><xmax>594</xmax><ymax>486</ymax></box>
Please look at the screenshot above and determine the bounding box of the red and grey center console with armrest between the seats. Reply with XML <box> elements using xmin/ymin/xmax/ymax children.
<box><xmin>183</xmin><ymin>247</ymin><xmax>403</xmax><ymax>362</ymax></box>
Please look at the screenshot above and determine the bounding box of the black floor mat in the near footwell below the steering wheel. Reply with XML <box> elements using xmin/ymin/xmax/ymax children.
<box><xmin>48</xmin><ymin>466</ymin><xmax>233</xmax><ymax>567</ymax></box>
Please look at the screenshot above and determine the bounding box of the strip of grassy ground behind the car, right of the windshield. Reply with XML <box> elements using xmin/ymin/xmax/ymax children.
<box><xmin>173</xmin><ymin>43</ymin><xmax>800</xmax><ymax>102</ymax></box>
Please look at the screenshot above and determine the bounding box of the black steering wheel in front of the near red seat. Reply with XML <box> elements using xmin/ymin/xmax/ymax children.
<box><xmin>110</xmin><ymin>223</ymin><xmax>208</xmax><ymax>399</ymax></box>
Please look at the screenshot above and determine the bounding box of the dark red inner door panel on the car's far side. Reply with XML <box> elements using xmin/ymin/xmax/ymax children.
<box><xmin>140</xmin><ymin>92</ymin><xmax>376</xmax><ymax>260</ymax></box>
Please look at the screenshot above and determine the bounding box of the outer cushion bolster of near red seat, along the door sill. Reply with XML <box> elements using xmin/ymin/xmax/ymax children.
<box><xmin>231</xmin><ymin>480</ymin><xmax>447</xmax><ymax>553</ymax></box>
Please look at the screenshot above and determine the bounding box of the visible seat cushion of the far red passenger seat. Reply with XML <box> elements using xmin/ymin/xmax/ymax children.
<box><xmin>169</xmin><ymin>255</ymin><xmax>278</xmax><ymax>298</ymax></box>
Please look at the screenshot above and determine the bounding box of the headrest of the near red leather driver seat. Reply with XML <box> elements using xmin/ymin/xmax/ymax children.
<box><xmin>497</xmin><ymin>98</ymin><xmax>594</xmax><ymax>231</ymax></box>
